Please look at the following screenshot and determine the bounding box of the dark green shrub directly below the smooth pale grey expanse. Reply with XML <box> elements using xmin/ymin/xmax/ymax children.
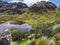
<box><xmin>11</xmin><ymin>30</ymin><xmax>26</xmax><ymax>41</ymax></box>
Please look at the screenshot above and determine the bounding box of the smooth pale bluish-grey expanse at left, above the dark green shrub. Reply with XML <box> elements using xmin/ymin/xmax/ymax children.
<box><xmin>0</xmin><ymin>22</ymin><xmax>32</xmax><ymax>32</ymax></box>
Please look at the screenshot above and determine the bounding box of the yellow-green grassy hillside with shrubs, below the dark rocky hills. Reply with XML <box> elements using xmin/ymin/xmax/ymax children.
<box><xmin>0</xmin><ymin>6</ymin><xmax>60</xmax><ymax>45</ymax></box>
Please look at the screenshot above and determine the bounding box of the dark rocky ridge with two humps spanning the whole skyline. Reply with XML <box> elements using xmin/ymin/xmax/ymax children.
<box><xmin>0</xmin><ymin>1</ymin><xmax>57</xmax><ymax>14</ymax></box>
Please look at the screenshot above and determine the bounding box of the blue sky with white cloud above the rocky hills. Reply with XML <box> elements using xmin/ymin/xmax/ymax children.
<box><xmin>4</xmin><ymin>0</ymin><xmax>60</xmax><ymax>6</ymax></box>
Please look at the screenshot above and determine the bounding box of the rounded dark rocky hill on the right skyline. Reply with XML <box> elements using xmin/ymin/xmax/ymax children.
<box><xmin>30</xmin><ymin>1</ymin><xmax>57</xmax><ymax>12</ymax></box>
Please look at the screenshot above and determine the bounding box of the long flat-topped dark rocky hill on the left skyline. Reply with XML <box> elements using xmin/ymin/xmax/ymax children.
<box><xmin>0</xmin><ymin>1</ymin><xmax>28</xmax><ymax>14</ymax></box>
